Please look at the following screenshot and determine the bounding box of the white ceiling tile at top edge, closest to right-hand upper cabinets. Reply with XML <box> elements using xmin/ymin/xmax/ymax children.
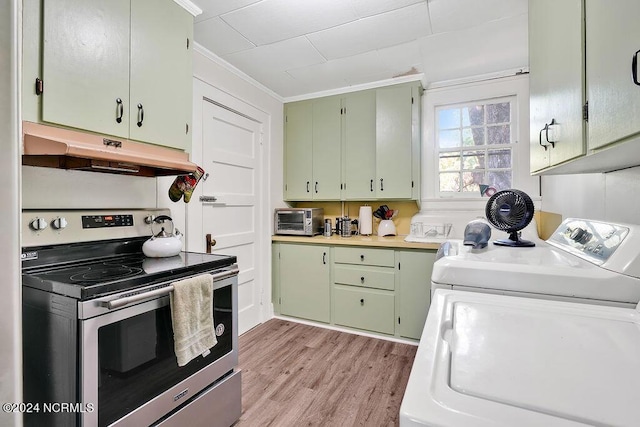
<box><xmin>429</xmin><ymin>0</ymin><xmax>529</xmax><ymax>33</ymax></box>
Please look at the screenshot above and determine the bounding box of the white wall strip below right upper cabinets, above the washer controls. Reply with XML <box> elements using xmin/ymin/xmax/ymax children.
<box><xmin>542</xmin><ymin>167</ymin><xmax>640</xmax><ymax>224</ymax></box>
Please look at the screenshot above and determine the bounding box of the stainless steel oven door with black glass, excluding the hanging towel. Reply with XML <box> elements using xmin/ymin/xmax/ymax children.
<box><xmin>80</xmin><ymin>275</ymin><xmax>238</xmax><ymax>426</ymax></box>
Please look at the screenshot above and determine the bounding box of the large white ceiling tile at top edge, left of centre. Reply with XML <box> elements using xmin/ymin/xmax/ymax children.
<box><xmin>222</xmin><ymin>0</ymin><xmax>357</xmax><ymax>46</ymax></box>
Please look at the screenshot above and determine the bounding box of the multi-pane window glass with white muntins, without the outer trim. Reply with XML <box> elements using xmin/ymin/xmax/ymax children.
<box><xmin>435</xmin><ymin>97</ymin><xmax>515</xmax><ymax>196</ymax></box>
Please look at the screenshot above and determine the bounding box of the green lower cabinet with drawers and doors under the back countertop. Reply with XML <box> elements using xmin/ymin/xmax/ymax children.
<box><xmin>272</xmin><ymin>243</ymin><xmax>436</xmax><ymax>340</ymax></box>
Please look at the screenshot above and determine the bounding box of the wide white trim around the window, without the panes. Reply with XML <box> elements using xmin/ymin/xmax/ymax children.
<box><xmin>421</xmin><ymin>74</ymin><xmax>540</xmax><ymax>210</ymax></box>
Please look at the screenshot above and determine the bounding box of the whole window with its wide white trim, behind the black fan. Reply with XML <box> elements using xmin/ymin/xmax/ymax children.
<box><xmin>422</xmin><ymin>74</ymin><xmax>540</xmax><ymax>206</ymax></box>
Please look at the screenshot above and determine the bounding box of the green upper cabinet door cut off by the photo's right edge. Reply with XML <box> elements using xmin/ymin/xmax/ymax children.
<box><xmin>585</xmin><ymin>0</ymin><xmax>640</xmax><ymax>149</ymax></box>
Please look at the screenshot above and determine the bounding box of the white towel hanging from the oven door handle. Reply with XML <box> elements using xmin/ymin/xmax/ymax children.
<box><xmin>170</xmin><ymin>274</ymin><xmax>218</xmax><ymax>366</ymax></box>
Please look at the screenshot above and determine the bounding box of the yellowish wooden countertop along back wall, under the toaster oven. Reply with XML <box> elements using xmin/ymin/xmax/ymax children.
<box><xmin>271</xmin><ymin>234</ymin><xmax>440</xmax><ymax>250</ymax></box>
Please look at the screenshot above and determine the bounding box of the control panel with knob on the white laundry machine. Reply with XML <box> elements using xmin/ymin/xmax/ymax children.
<box><xmin>547</xmin><ymin>218</ymin><xmax>629</xmax><ymax>265</ymax></box>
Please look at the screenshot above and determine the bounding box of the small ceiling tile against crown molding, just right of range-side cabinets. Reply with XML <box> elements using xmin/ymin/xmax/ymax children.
<box><xmin>193</xmin><ymin>18</ymin><xmax>255</xmax><ymax>56</ymax></box>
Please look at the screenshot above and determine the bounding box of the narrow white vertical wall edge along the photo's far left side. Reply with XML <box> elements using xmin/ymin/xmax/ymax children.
<box><xmin>0</xmin><ymin>0</ymin><xmax>22</xmax><ymax>426</ymax></box>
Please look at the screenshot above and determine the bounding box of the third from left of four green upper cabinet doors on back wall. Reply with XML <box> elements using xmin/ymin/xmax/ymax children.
<box><xmin>343</xmin><ymin>90</ymin><xmax>376</xmax><ymax>200</ymax></box>
